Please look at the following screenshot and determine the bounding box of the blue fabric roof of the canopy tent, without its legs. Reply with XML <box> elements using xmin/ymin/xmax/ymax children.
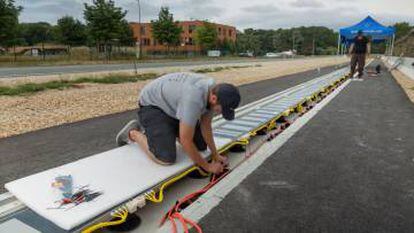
<box><xmin>339</xmin><ymin>16</ymin><xmax>395</xmax><ymax>41</ymax></box>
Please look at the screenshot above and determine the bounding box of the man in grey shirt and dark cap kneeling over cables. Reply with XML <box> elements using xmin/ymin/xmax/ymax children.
<box><xmin>116</xmin><ymin>73</ymin><xmax>241</xmax><ymax>173</ymax></box>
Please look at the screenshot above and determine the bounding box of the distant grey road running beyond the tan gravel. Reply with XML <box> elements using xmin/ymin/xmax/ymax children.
<box><xmin>0</xmin><ymin>58</ymin><xmax>294</xmax><ymax>78</ymax></box>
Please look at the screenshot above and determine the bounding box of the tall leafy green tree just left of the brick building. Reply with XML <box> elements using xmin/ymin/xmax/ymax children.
<box><xmin>83</xmin><ymin>0</ymin><xmax>131</xmax><ymax>58</ymax></box>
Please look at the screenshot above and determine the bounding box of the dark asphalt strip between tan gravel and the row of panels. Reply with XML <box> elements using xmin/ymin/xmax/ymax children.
<box><xmin>0</xmin><ymin>62</ymin><xmax>344</xmax><ymax>193</ymax></box>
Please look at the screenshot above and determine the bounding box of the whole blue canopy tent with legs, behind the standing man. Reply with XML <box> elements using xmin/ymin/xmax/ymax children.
<box><xmin>338</xmin><ymin>16</ymin><xmax>395</xmax><ymax>54</ymax></box>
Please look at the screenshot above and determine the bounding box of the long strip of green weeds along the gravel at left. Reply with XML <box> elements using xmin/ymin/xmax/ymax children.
<box><xmin>0</xmin><ymin>73</ymin><xmax>158</xmax><ymax>96</ymax></box>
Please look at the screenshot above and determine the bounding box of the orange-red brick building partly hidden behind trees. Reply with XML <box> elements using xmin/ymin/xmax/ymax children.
<box><xmin>130</xmin><ymin>20</ymin><xmax>237</xmax><ymax>52</ymax></box>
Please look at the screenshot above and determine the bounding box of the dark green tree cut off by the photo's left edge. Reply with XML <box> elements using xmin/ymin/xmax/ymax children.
<box><xmin>0</xmin><ymin>0</ymin><xmax>23</xmax><ymax>46</ymax></box>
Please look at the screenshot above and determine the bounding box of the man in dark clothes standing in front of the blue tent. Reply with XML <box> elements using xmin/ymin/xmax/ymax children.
<box><xmin>349</xmin><ymin>30</ymin><xmax>371</xmax><ymax>78</ymax></box>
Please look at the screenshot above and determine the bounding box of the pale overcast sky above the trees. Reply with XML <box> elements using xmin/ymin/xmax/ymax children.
<box><xmin>16</xmin><ymin>0</ymin><xmax>414</xmax><ymax>30</ymax></box>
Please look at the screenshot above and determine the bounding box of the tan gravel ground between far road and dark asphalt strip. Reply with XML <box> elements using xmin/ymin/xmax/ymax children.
<box><xmin>0</xmin><ymin>57</ymin><xmax>348</xmax><ymax>138</ymax></box>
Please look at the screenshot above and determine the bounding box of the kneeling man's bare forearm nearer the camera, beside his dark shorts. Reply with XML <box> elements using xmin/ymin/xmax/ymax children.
<box><xmin>180</xmin><ymin>122</ymin><xmax>223</xmax><ymax>173</ymax></box>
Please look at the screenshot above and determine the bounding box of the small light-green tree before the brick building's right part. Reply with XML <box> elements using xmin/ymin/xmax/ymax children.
<box><xmin>195</xmin><ymin>21</ymin><xmax>218</xmax><ymax>51</ymax></box>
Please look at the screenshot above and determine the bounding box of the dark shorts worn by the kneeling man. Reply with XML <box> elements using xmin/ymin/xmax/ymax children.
<box><xmin>138</xmin><ymin>106</ymin><xmax>207</xmax><ymax>163</ymax></box>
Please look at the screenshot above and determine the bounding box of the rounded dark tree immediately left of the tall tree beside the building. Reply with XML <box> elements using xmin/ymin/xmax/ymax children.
<box><xmin>56</xmin><ymin>16</ymin><xmax>86</xmax><ymax>46</ymax></box>
